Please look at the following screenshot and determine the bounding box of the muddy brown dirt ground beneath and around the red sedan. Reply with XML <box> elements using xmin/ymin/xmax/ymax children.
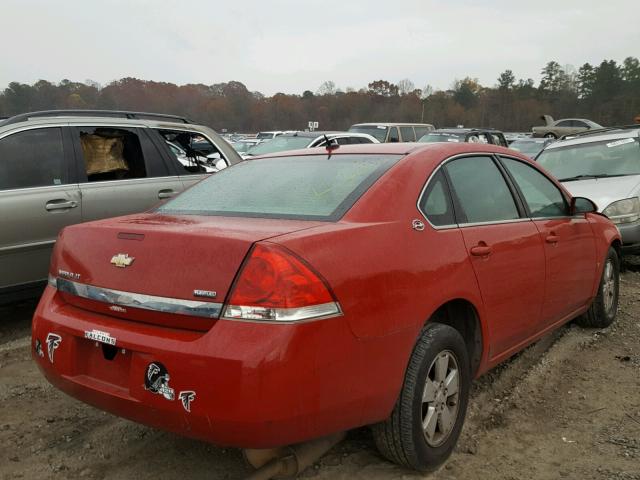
<box><xmin>0</xmin><ymin>267</ymin><xmax>640</xmax><ymax>480</ymax></box>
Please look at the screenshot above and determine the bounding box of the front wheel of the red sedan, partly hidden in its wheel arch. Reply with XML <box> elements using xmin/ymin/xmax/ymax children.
<box><xmin>576</xmin><ymin>248</ymin><xmax>620</xmax><ymax>328</ymax></box>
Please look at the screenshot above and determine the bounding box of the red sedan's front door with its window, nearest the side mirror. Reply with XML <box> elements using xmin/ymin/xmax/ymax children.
<box><xmin>501</xmin><ymin>157</ymin><xmax>596</xmax><ymax>326</ymax></box>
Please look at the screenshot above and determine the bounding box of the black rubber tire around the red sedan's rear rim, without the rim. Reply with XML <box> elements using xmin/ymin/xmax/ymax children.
<box><xmin>372</xmin><ymin>323</ymin><xmax>471</xmax><ymax>472</ymax></box>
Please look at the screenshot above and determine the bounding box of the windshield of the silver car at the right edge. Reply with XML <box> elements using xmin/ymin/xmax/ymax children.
<box><xmin>537</xmin><ymin>137</ymin><xmax>640</xmax><ymax>181</ymax></box>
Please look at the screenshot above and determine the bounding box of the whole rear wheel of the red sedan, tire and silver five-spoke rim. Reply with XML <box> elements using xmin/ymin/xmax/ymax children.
<box><xmin>373</xmin><ymin>323</ymin><xmax>471</xmax><ymax>471</ymax></box>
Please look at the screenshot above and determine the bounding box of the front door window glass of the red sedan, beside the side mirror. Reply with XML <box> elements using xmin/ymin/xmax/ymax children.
<box><xmin>502</xmin><ymin>158</ymin><xmax>567</xmax><ymax>218</ymax></box>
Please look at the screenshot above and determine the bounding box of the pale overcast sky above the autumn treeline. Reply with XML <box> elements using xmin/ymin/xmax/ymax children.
<box><xmin>0</xmin><ymin>0</ymin><xmax>640</xmax><ymax>95</ymax></box>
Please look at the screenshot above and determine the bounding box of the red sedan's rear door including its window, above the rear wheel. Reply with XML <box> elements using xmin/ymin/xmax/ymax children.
<box><xmin>445</xmin><ymin>155</ymin><xmax>545</xmax><ymax>358</ymax></box>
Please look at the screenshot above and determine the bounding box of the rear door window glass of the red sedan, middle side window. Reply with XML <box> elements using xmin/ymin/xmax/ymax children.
<box><xmin>446</xmin><ymin>157</ymin><xmax>519</xmax><ymax>223</ymax></box>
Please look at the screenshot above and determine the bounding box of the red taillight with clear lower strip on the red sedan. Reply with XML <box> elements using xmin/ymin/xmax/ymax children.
<box><xmin>222</xmin><ymin>244</ymin><xmax>340</xmax><ymax>322</ymax></box>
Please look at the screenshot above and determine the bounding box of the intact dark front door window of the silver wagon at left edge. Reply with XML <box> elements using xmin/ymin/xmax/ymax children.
<box><xmin>0</xmin><ymin>128</ymin><xmax>67</xmax><ymax>190</ymax></box>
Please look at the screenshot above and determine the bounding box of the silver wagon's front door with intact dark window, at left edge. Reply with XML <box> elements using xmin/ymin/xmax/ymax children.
<box><xmin>0</xmin><ymin>126</ymin><xmax>82</xmax><ymax>289</ymax></box>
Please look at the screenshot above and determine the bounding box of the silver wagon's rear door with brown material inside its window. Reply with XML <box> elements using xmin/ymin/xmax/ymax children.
<box><xmin>72</xmin><ymin>125</ymin><xmax>183</xmax><ymax>221</ymax></box>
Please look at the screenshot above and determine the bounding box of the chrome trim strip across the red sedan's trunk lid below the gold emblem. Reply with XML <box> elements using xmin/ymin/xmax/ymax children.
<box><xmin>56</xmin><ymin>277</ymin><xmax>222</xmax><ymax>318</ymax></box>
